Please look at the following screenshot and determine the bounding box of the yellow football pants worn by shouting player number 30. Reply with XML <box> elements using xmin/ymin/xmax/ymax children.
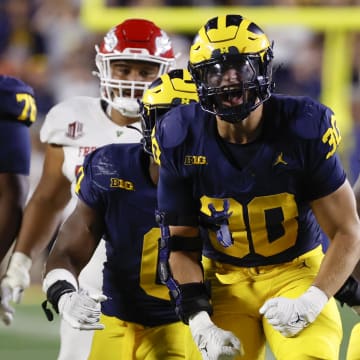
<box><xmin>187</xmin><ymin>247</ymin><xmax>344</xmax><ymax>360</ymax></box>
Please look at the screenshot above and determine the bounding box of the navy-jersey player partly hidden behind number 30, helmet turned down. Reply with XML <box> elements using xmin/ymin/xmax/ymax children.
<box><xmin>43</xmin><ymin>69</ymin><xmax>198</xmax><ymax>360</ymax></box>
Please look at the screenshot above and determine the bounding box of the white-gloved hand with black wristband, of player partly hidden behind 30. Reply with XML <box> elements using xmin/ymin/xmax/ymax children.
<box><xmin>58</xmin><ymin>290</ymin><xmax>107</xmax><ymax>330</ymax></box>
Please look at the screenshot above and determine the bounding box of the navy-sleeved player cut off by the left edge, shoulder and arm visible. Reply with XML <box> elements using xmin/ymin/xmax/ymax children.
<box><xmin>0</xmin><ymin>75</ymin><xmax>37</xmax><ymax>325</ymax></box>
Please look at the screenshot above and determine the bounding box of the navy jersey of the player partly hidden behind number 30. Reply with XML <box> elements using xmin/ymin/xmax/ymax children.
<box><xmin>77</xmin><ymin>144</ymin><xmax>178</xmax><ymax>326</ymax></box>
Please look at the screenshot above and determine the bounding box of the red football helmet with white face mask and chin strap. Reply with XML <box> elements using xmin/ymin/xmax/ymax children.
<box><xmin>95</xmin><ymin>19</ymin><xmax>175</xmax><ymax>117</ymax></box>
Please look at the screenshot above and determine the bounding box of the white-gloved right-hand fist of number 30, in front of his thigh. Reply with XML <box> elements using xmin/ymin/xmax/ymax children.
<box><xmin>259</xmin><ymin>286</ymin><xmax>328</xmax><ymax>337</ymax></box>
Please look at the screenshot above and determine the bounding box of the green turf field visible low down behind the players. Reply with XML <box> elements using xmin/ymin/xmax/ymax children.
<box><xmin>0</xmin><ymin>287</ymin><xmax>358</xmax><ymax>360</ymax></box>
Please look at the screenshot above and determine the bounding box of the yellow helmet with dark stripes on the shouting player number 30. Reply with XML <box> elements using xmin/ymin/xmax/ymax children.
<box><xmin>189</xmin><ymin>15</ymin><xmax>274</xmax><ymax>123</ymax></box>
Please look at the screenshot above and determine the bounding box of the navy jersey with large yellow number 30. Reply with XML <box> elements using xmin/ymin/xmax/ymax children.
<box><xmin>154</xmin><ymin>95</ymin><xmax>346</xmax><ymax>267</ymax></box>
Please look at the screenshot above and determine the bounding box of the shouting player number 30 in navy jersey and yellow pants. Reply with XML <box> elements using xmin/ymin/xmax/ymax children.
<box><xmin>153</xmin><ymin>15</ymin><xmax>360</xmax><ymax>360</ymax></box>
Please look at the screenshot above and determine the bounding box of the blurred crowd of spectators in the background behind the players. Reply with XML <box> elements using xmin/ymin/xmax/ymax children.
<box><xmin>0</xmin><ymin>0</ymin><xmax>360</xmax><ymax>280</ymax></box>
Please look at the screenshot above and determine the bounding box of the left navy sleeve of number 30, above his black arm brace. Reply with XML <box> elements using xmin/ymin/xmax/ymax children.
<box><xmin>155</xmin><ymin>113</ymin><xmax>200</xmax><ymax>226</ymax></box>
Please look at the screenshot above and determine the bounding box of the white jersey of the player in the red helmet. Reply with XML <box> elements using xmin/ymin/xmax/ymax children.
<box><xmin>40</xmin><ymin>96</ymin><xmax>142</xmax><ymax>183</ymax></box>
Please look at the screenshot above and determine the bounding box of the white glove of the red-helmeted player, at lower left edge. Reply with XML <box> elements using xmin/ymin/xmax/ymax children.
<box><xmin>0</xmin><ymin>251</ymin><xmax>32</xmax><ymax>325</ymax></box>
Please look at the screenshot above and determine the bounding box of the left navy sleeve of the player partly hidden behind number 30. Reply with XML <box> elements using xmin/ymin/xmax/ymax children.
<box><xmin>76</xmin><ymin>151</ymin><xmax>104</xmax><ymax>211</ymax></box>
